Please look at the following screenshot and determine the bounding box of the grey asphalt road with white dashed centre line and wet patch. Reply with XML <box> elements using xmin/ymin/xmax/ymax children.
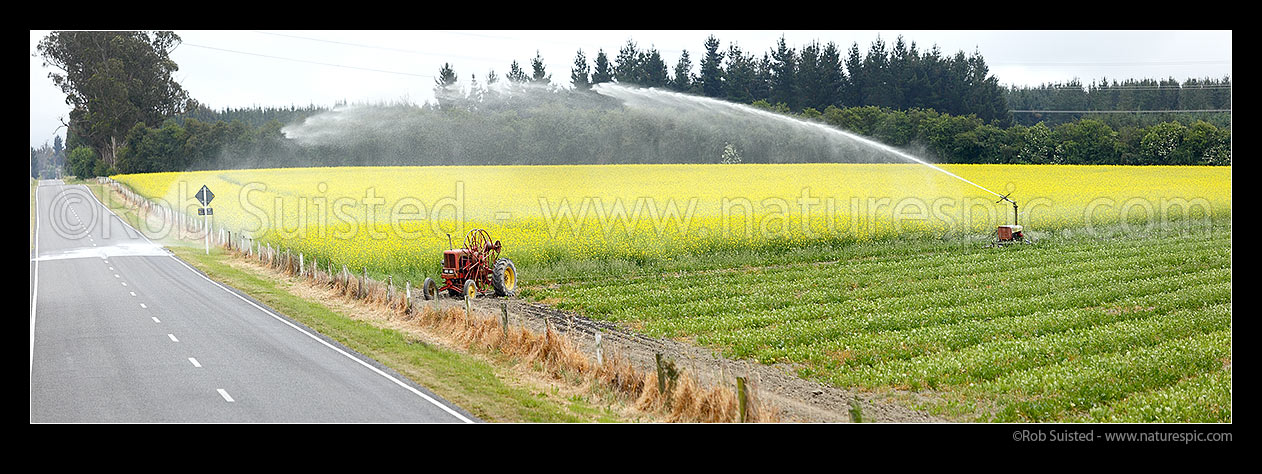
<box><xmin>30</xmin><ymin>182</ymin><xmax>477</xmax><ymax>424</ymax></box>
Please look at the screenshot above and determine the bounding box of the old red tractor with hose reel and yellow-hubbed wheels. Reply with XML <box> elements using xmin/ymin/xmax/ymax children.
<box><xmin>422</xmin><ymin>228</ymin><xmax>517</xmax><ymax>300</ymax></box>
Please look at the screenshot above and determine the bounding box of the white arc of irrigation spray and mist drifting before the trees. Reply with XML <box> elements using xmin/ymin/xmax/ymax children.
<box><xmin>271</xmin><ymin>86</ymin><xmax>905</xmax><ymax>165</ymax></box>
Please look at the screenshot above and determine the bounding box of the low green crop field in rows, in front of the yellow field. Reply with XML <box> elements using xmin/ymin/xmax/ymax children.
<box><xmin>531</xmin><ymin>229</ymin><xmax>1232</xmax><ymax>422</ymax></box>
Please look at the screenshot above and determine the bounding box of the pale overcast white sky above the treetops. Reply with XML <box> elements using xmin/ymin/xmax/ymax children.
<box><xmin>30</xmin><ymin>30</ymin><xmax>1232</xmax><ymax>147</ymax></box>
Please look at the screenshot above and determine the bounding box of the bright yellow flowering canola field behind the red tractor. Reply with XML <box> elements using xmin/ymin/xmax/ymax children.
<box><xmin>114</xmin><ymin>164</ymin><xmax>1232</xmax><ymax>274</ymax></box>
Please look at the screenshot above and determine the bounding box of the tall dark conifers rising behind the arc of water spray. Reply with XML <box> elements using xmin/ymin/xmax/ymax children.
<box><xmin>434</xmin><ymin>35</ymin><xmax>1012</xmax><ymax>126</ymax></box>
